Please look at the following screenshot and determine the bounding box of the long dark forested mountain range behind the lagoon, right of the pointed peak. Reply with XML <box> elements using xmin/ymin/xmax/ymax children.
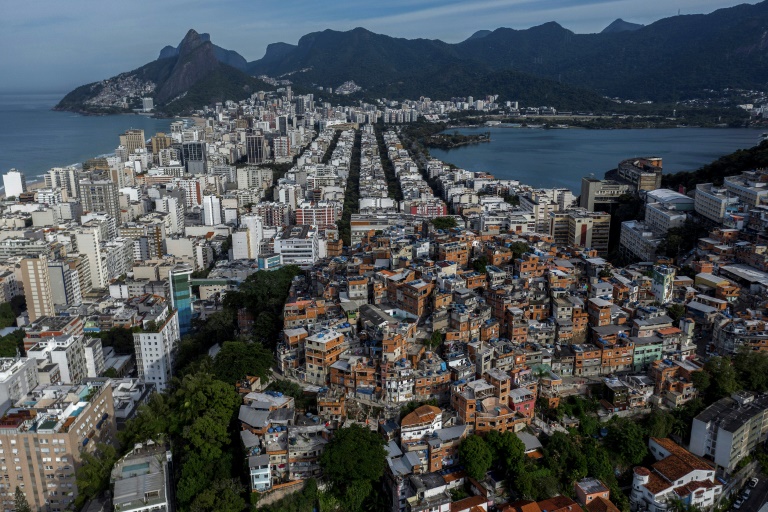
<box><xmin>248</xmin><ymin>1</ymin><xmax>768</xmax><ymax>101</ymax></box>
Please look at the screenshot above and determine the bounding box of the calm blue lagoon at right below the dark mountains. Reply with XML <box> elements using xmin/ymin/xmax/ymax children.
<box><xmin>429</xmin><ymin>127</ymin><xmax>762</xmax><ymax>194</ymax></box>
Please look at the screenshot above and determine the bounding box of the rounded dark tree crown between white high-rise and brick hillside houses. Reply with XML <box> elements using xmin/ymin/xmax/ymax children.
<box><xmin>213</xmin><ymin>341</ymin><xmax>274</xmax><ymax>384</ymax></box>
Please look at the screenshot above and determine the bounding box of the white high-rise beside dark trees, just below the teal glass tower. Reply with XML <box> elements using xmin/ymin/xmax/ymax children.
<box><xmin>133</xmin><ymin>304</ymin><xmax>180</xmax><ymax>393</ymax></box>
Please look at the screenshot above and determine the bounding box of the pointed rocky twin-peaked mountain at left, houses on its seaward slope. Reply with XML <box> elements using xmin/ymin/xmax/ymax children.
<box><xmin>55</xmin><ymin>30</ymin><xmax>273</xmax><ymax>114</ymax></box>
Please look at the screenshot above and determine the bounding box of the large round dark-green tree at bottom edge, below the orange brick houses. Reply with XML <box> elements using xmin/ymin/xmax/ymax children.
<box><xmin>320</xmin><ymin>424</ymin><xmax>387</xmax><ymax>511</ymax></box>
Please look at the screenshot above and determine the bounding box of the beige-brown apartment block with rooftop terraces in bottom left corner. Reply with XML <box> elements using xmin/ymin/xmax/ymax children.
<box><xmin>0</xmin><ymin>379</ymin><xmax>116</xmax><ymax>512</ymax></box>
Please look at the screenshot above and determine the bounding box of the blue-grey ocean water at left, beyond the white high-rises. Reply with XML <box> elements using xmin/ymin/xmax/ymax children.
<box><xmin>0</xmin><ymin>93</ymin><xmax>172</xmax><ymax>185</ymax></box>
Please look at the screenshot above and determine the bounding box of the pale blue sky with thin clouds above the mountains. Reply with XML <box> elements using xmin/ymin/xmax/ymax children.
<box><xmin>0</xmin><ymin>0</ymin><xmax>756</xmax><ymax>93</ymax></box>
